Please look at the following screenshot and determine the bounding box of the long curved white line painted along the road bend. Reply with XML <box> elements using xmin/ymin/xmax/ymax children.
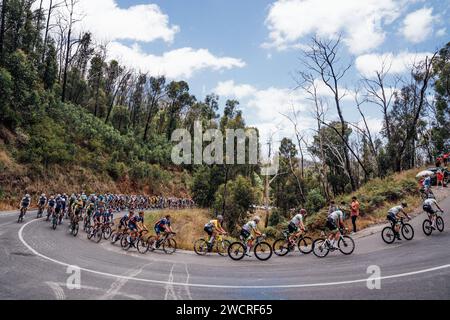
<box><xmin>18</xmin><ymin>220</ymin><xmax>450</xmax><ymax>289</ymax></box>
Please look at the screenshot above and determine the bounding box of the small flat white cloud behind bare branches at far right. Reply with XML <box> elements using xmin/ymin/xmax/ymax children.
<box><xmin>356</xmin><ymin>51</ymin><xmax>433</xmax><ymax>77</ymax></box>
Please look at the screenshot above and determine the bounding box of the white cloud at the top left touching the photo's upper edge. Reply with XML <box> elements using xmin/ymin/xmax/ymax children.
<box><xmin>34</xmin><ymin>0</ymin><xmax>180</xmax><ymax>43</ymax></box>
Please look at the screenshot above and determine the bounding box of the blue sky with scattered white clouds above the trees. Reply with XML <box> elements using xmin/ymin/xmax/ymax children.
<box><xmin>60</xmin><ymin>0</ymin><xmax>450</xmax><ymax>151</ymax></box>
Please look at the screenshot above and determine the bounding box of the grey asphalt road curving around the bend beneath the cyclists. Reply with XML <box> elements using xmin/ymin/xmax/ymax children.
<box><xmin>0</xmin><ymin>198</ymin><xmax>450</xmax><ymax>300</ymax></box>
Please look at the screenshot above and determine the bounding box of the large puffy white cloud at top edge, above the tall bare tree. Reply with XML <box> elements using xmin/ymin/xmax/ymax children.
<box><xmin>263</xmin><ymin>0</ymin><xmax>406</xmax><ymax>54</ymax></box>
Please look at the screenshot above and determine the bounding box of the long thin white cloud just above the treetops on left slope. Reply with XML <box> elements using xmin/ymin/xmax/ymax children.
<box><xmin>108</xmin><ymin>42</ymin><xmax>245</xmax><ymax>79</ymax></box>
